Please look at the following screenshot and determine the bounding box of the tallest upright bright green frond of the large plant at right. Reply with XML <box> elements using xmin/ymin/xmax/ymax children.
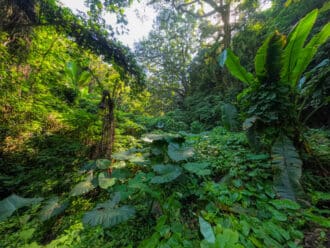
<box><xmin>281</xmin><ymin>9</ymin><xmax>318</xmax><ymax>86</ymax></box>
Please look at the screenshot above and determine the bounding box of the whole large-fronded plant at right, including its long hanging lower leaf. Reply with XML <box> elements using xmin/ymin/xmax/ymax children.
<box><xmin>219</xmin><ymin>9</ymin><xmax>330</xmax><ymax>200</ymax></box>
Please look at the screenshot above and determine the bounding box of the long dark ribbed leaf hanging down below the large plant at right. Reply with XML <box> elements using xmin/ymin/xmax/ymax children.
<box><xmin>272</xmin><ymin>136</ymin><xmax>303</xmax><ymax>201</ymax></box>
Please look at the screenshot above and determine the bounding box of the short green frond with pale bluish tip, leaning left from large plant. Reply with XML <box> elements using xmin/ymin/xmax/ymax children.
<box><xmin>218</xmin><ymin>49</ymin><xmax>255</xmax><ymax>85</ymax></box>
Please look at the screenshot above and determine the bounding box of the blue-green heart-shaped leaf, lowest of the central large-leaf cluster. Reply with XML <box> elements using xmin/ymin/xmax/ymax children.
<box><xmin>150</xmin><ymin>164</ymin><xmax>182</xmax><ymax>184</ymax></box>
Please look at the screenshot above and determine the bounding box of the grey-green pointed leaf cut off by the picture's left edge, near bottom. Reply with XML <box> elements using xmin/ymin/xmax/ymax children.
<box><xmin>0</xmin><ymin>194</ymin><xmax>42</xmax><ymax>221</ymax></box>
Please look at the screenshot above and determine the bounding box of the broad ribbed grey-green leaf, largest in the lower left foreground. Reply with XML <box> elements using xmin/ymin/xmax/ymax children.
<box><xmin>83</xmin><ymin>200</ymin><xmax>135</xmax><ymax>228</ymax></box>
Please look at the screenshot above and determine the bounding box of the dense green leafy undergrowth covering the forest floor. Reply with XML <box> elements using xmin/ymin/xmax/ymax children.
<box><xmin>0</xmin><ymin>127</ymin><xmax>330</xmax><ymax>248</ymax></box>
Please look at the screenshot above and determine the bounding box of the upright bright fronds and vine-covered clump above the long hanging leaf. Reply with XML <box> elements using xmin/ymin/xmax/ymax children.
<box><xmin>219</xmin><ymin>9</ymin><xmax>330</xmax><ymax>143</ymax></box>
